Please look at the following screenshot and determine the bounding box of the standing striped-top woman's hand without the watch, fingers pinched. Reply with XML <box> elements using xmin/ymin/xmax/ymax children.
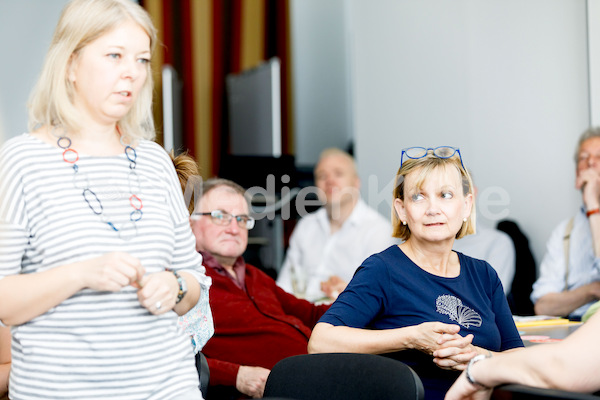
<box><xmin>79</xmin><ymin>252</ymin><xmax>145</xmax><ymax>292</ymax></box>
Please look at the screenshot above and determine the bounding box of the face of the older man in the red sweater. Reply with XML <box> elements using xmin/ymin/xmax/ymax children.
<box><xmin>191</xmin><ymin>187</ymin><xmax>248</xmax><ymax>265</ymax></box>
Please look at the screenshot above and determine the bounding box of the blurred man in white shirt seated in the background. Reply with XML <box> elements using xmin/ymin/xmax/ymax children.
<box><xmin>277</xmin><ymin>149</ymin><xmax>397</xmax><ymax>301</ymax></box>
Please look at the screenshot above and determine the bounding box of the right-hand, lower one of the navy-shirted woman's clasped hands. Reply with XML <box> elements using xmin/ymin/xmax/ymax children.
<box><xmin>433</xmin><ymin>333</ymin><xmax>477</xmax><ymax>371</ymax></box>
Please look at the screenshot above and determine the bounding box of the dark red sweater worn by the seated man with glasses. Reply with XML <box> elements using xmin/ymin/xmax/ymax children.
<box><xmin>202</xmin><ymin>255</ymin><xmax>329</xmax><ymax>387</ymax></box>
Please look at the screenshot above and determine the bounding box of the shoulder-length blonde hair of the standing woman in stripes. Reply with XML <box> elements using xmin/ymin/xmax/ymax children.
<box><xmin>28</xmin><ymin>0</ymin><xmax>156</xmax><ymax>140</ymax></box>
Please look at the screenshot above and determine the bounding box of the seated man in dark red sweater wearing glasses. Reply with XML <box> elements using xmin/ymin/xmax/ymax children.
<box><xmin>190</xmin><ymin>179</ymin><xmax>328</xmax><ymax>399</ymax></box>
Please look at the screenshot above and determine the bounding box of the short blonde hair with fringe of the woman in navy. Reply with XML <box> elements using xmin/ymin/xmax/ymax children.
<box><xmin>392</xmin><ymin>152</ymin><xmax>476</xmax><ymax>240</ymax></box>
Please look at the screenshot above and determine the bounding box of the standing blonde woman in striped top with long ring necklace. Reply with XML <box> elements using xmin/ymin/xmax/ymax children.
<box><xmin>0</xmin><ymin>0</ymin><xmax>210</xmax><ymax>400</ymax></box>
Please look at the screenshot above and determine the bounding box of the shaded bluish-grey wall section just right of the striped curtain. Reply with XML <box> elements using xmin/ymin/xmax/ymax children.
<box><xmin>290</xmin><ymin>0</ymin><xmax>353</xmax><ymax>166</ymax></box>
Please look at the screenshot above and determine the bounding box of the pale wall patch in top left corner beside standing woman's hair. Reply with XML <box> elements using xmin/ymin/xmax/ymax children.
<box><xmin>0</xmin><ymin>0</ymin><xmax>67</xmax><ymax>141</ymax></box>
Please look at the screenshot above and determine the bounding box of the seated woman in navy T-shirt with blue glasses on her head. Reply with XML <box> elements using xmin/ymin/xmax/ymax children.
<box><xmin>309</xmin><ymin>146</ymin><xmax>523</xmax><ymax>399</ymax></box>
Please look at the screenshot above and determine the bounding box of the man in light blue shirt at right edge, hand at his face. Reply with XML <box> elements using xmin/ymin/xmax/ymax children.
<box><xmin>531</xmin><ymin>127</ymin><xmax>600</xmax><ymax>319</ymax></box>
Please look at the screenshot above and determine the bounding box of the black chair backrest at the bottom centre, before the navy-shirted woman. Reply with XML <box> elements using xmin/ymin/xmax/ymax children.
<box><xmin>264</xmin><ymin>353</ymin><xmax>424</xmax><ymax>400</ymax></box>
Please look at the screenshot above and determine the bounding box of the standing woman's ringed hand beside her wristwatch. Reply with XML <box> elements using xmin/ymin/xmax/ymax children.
<box><xmin>138</xmin><ymin>271</ymin><xmax>179</xmax><ymax>315</ymax></box>
